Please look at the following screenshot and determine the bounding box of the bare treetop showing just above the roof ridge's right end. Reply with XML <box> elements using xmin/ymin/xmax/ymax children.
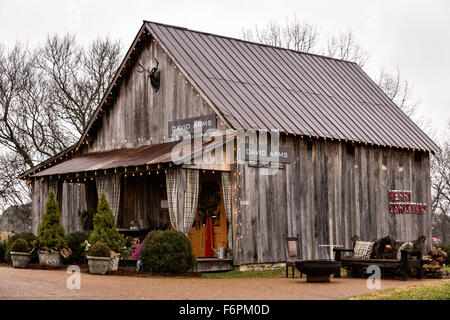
<box><xmin>324</xmin><ymin>30</ymin><xmax>369</xmax><ymax>68</ymax></box>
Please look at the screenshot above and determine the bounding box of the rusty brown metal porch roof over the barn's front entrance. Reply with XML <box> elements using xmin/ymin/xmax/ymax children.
<box><xmin>32</xmin><ymin>139</ymin><xmax>220</xmax><ymax>177</ymax></box>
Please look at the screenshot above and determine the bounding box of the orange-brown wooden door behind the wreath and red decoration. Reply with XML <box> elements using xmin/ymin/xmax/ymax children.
<box><xmin>189</xmin><ymin>173</ymin><xmax>228</xmax><ymax>258</ymax></box>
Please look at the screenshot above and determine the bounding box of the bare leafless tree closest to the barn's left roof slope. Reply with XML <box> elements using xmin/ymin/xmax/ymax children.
<box><xmin>36</xmin><ymin>35</ymin><xmax>121</xmax><ymax>139</ymax></box>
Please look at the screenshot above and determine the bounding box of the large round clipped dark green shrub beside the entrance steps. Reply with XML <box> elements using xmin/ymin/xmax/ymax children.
<box><xmin>139</xmin><ymin>230</ymin><xmax>196</xmax><ymax>274</ymax></box>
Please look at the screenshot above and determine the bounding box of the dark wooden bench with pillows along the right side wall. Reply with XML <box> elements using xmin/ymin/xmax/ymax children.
<box><xmin>333</xmin><ymin>235</ymin><xmax>426</xmax><ymax>281</ymax></box>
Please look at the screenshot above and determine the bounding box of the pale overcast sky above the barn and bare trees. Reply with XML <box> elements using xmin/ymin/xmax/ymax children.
<box><xmin>0</xmin><ymin>0</ymin><xmax>450</xmax><ymax>139</ymax></box>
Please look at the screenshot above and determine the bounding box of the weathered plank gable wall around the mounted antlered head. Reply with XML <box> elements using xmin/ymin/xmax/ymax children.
<box><xmin>89</xmin><ymin>37</ymin><xmax>224</xmax><ymax>151</ymax></box>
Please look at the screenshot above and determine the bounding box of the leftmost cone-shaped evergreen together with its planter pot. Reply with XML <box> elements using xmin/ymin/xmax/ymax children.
<box><xmin>35</xmin><ymin>189</ymin><xmax>71</xmax><ymax>267</ymax></box>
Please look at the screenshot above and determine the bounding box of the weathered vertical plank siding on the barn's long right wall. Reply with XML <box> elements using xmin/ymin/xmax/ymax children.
<box><xmin>234</xmin><ymin>137</ymin><xmax>431</xmax><ymax>264</ymax></box>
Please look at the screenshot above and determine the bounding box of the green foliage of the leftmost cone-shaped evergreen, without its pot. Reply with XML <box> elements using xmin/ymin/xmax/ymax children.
<box><xmin>38</xmin><ymin>189</ymin><xmax>66</xmax><ymax>250</ymax></box>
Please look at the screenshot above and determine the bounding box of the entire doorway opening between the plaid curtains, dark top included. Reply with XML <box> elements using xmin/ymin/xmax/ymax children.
<box><xmin>188</xmin><ymin>171</ymin><xmax>228</xmax><ymax>258</ymax></box>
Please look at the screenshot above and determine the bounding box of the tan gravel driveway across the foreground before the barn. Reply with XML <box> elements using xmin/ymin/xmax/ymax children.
<box><xmin>0</xmin><ymin>268</ymin><xmax>439</xmax><ymax>300</ymax></box>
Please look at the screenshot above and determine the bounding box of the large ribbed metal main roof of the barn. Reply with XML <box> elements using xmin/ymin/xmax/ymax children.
<box><xmin>145</xmin><ymin>21</ymin><xmax>439</xmax><ymax>151</ymax></box>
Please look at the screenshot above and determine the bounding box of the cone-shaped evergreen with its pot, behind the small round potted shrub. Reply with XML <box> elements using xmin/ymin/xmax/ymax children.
<box><xmin>89</xmin><ymin>190</ymin><xmax>126</xmax><ymax>271</ymax></box>
